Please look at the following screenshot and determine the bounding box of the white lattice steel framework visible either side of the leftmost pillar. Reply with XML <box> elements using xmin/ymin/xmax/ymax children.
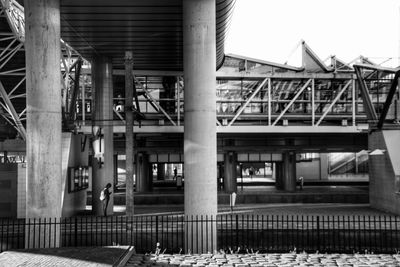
<box><xmin>0</xmin><ymin>0</ymin><xmax>83</xmax><ymax>136</ymax></box>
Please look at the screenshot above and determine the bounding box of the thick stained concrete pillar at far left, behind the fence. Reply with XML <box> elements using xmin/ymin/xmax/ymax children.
<box><xmin>25</xmin><ymin>0</ymin><xmax>62</xmax><ymax>247</ymax></box>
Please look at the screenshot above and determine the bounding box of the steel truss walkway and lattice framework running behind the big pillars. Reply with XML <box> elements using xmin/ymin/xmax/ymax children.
<box><xmin>0</xmin><ymin>0</ymin><xmax>400</xmax><ymax>140</ymax></box>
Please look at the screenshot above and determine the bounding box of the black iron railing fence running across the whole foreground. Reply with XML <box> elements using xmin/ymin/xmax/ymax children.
<box><xmin>0</xmin><ymin>214</ymin><xmax>400</xmax><ymax>253</ymax></box>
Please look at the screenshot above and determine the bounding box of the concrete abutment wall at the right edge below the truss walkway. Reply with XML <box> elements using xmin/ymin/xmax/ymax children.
<box><xmin>368</xmin><ymin>130</ymin><xmax>400</xmax><ymax>214</ymax></box>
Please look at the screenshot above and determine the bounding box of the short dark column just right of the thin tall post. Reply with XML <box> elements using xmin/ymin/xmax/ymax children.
<box><xmin>136</xmin><ymin>152</ymin><xmax>153</xmax><ymax>192</ymax></box>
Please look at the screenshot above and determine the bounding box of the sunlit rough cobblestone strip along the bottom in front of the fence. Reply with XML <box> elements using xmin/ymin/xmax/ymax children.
<box><xmin>126</xmin><ymin>253</ymin><xmax>400</xmax><ymax>267</ymax></box>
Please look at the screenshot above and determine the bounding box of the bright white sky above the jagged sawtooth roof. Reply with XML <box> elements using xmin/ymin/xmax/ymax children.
<box><xmin>225</xmin><ymin>0</ymin><xmax>400</xmax><ymax>66</ymax></box>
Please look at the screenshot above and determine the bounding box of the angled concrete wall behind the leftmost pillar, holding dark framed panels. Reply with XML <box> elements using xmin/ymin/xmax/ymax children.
<box><xmin>62</xmin><ymin>133</ymin><xmax>89</xmax><ymax>217</ymax></box>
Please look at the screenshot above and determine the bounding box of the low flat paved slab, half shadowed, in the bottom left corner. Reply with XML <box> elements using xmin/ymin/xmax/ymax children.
<box><xmin>0</xmin><ymin>246</ymin><xmax>127</xmax><ymax>267</ymax></box>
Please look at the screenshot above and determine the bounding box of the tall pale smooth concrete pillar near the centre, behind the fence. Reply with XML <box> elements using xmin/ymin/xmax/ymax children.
<box><xmin>183</xmin><ymin>0</ymin><xmax>217</xmax><ymax>253</ymax></box>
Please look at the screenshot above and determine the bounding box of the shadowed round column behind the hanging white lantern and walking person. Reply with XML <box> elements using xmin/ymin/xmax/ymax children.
<box><xmin>92</xmin><ymin>56</ymin><xmax>114</xmax><ymax>218</ymax></box>
